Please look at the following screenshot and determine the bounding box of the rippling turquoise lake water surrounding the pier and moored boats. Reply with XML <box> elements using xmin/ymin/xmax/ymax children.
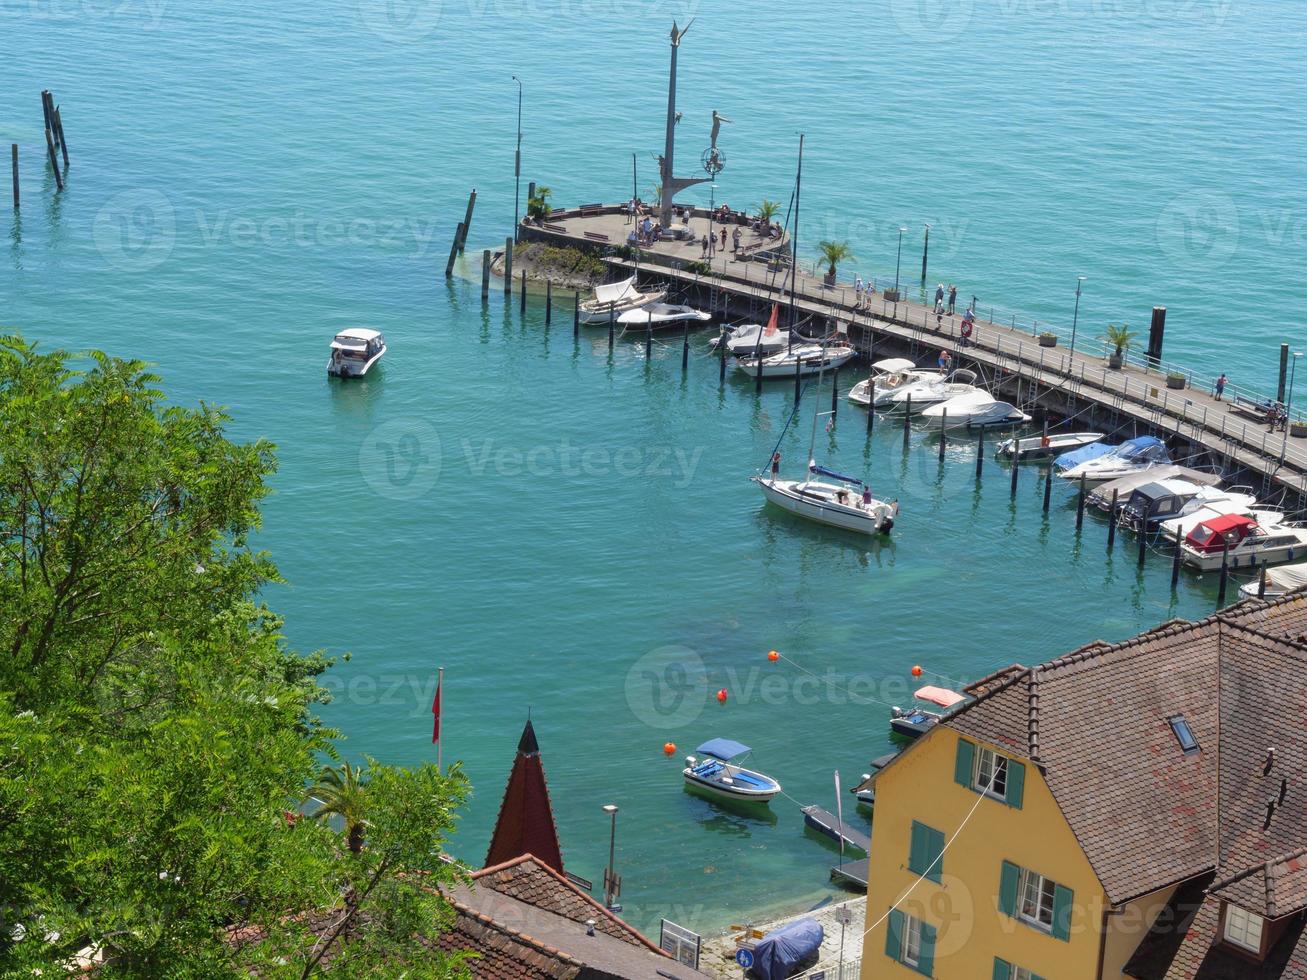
<box><xmin>0</xmin><ymin>0</ymin><xmax>1307</xmax><ymax>933</ymax></box>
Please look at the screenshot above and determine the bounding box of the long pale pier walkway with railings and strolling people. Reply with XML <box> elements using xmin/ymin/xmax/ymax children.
<box><xmin>521</xmin><ymin>205</ymin><xmax>1307</xmax><ymax>498</ymax></box>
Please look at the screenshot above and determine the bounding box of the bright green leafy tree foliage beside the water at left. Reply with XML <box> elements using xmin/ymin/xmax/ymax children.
<box><xmin>0</xmin><ymin>337</ymin><xmax>467</xmax><ymax>977</ymax></box>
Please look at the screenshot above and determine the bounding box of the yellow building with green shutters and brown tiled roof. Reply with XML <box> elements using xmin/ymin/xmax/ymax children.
<box><xmin>861</xmin><ymin>597</ymin><xmax>1307</xmax><ymax>980</ymax></box>
